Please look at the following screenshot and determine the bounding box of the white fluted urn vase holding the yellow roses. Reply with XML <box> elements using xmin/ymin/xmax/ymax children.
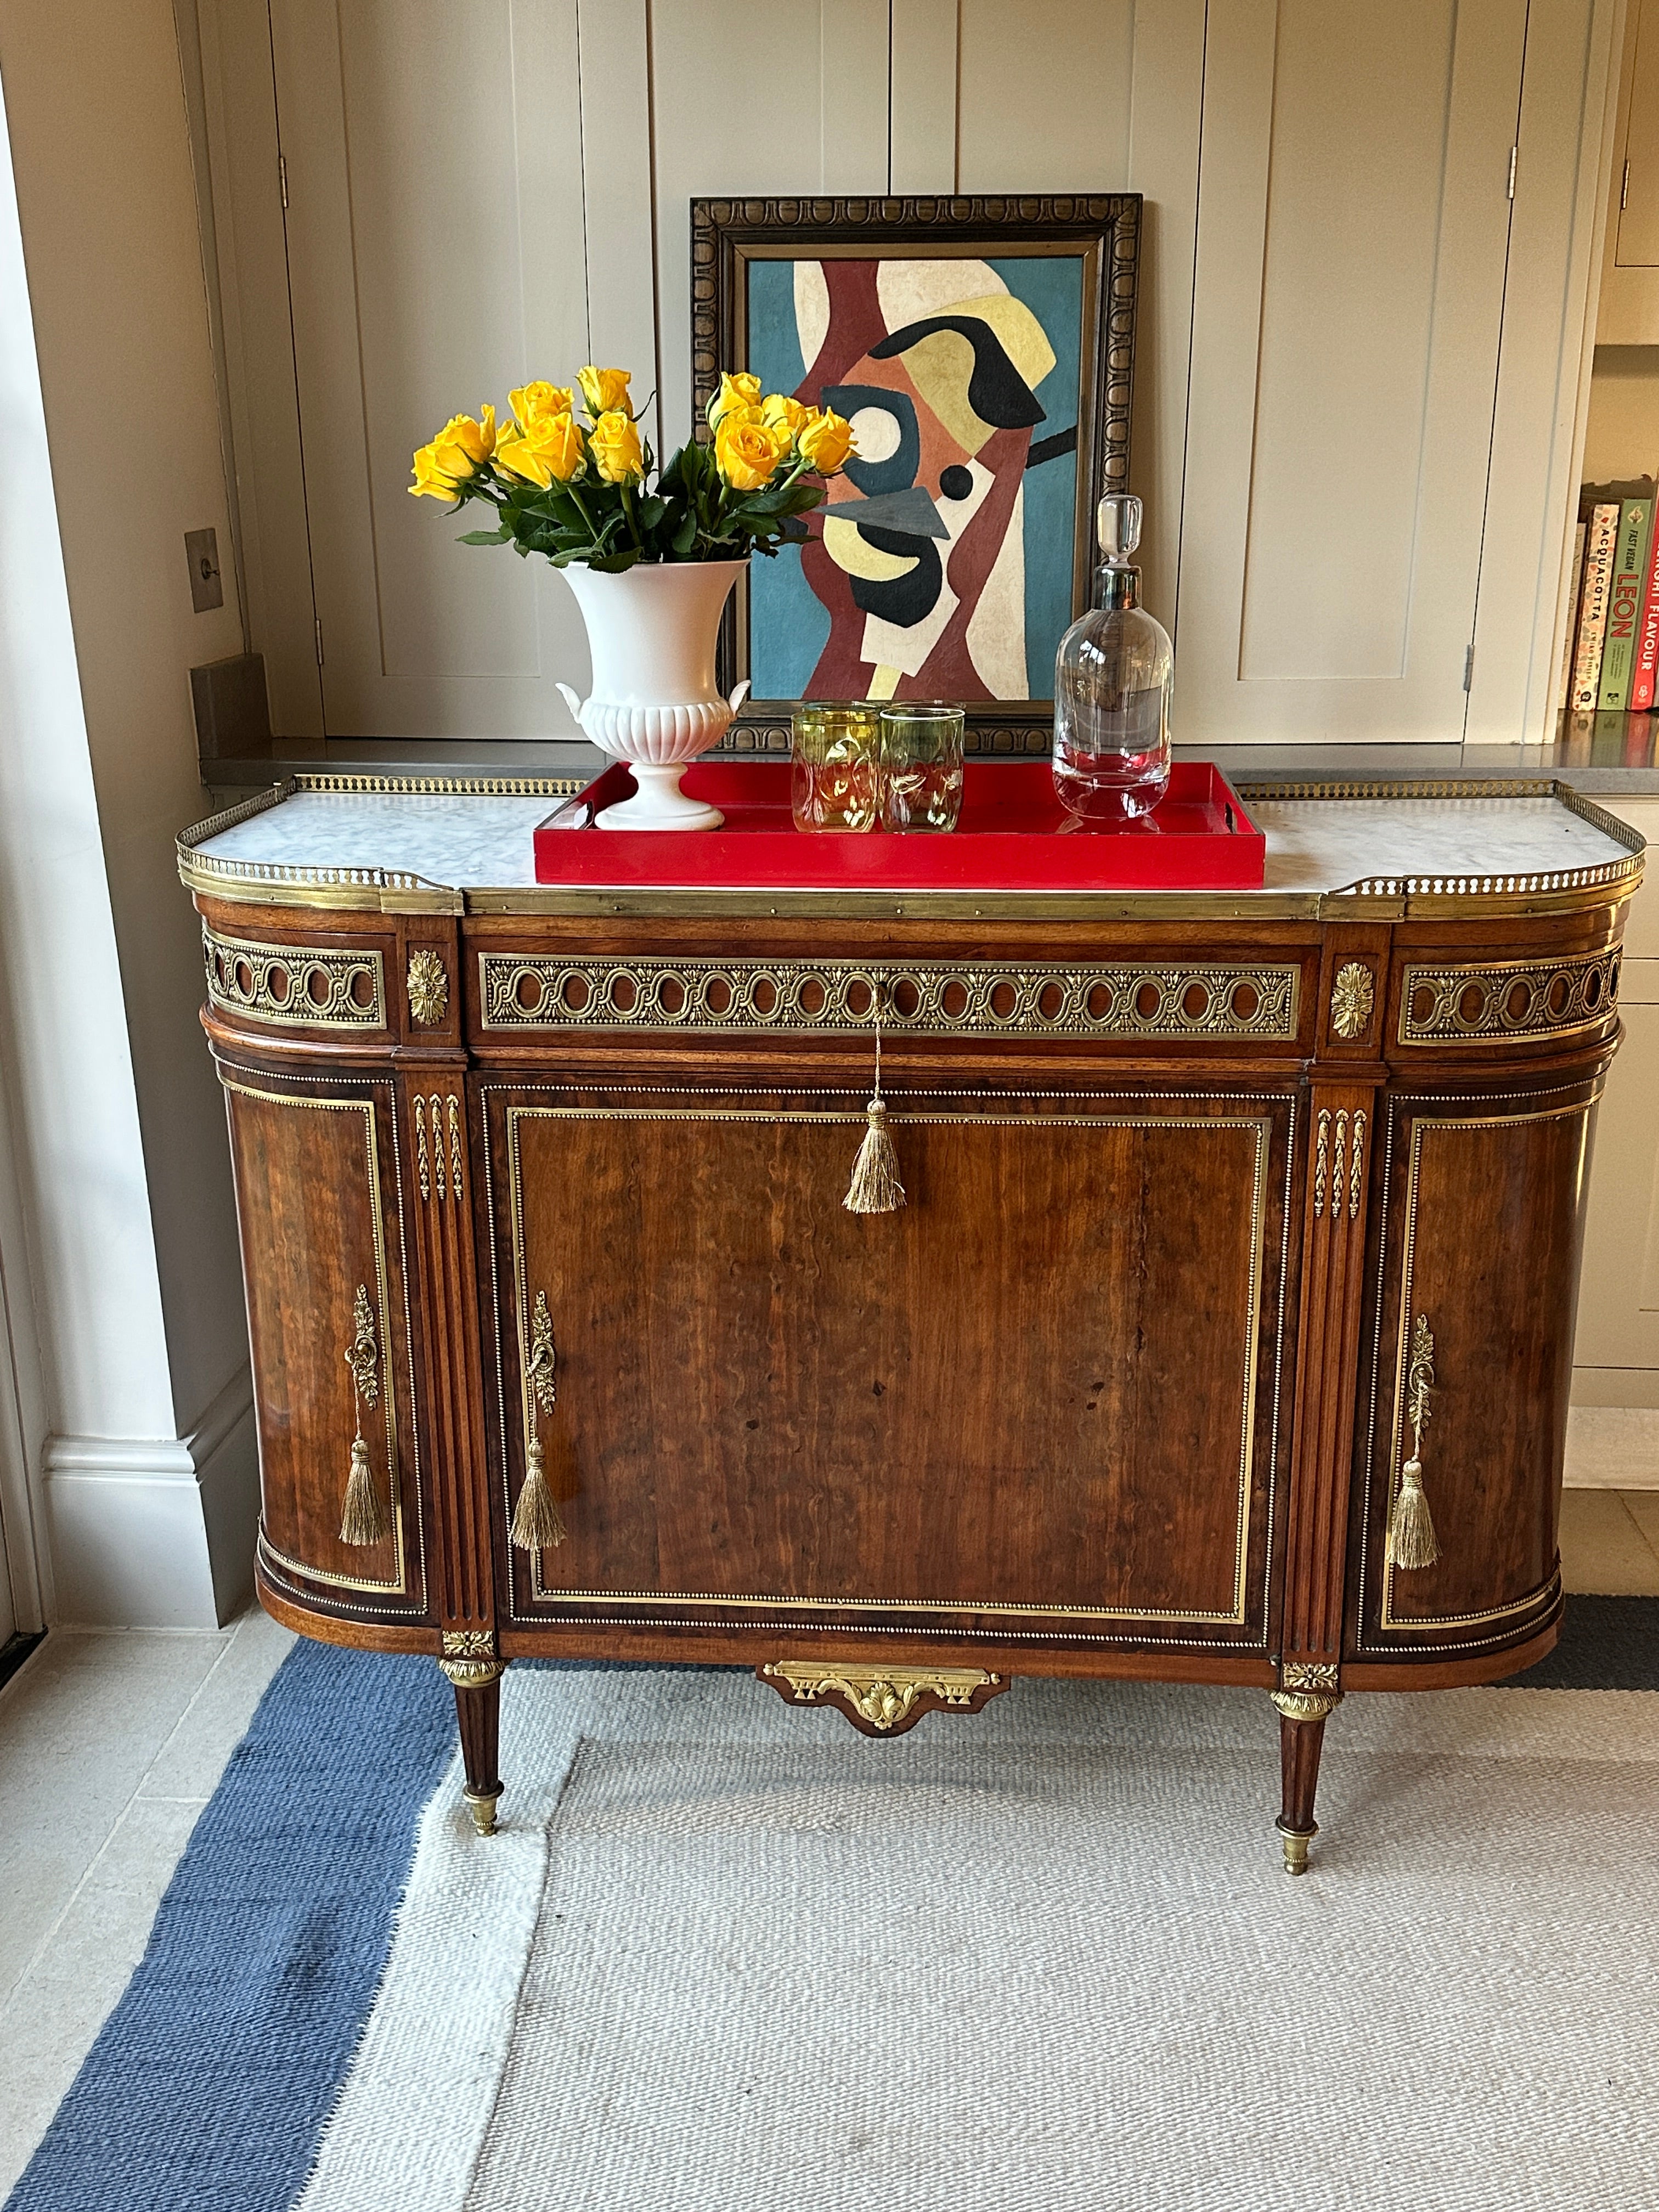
<box><xmin>560</xmin><ymin>560</ymin><xmax>748</xmax><ymax>830</ymax></box>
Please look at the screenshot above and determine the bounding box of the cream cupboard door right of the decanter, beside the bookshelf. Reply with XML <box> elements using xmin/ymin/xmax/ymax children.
<box><xmin>1175</xmin><ymin>0</ymin><xmax>1526</xmax><ymax>743</ymax></box>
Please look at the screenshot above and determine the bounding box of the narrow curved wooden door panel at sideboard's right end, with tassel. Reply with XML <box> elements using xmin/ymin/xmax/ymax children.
<box><xmin>1358</xmin><ymin>1084</ymin><xmax>1595</xmax><ymax>1652</ymax></box>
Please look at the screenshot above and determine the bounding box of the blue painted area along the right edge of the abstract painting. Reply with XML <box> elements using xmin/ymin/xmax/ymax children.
<box><xmin>991</xmin><ymin>255</ymin><xmax>1084</xmax><ymax>699</ymax></box>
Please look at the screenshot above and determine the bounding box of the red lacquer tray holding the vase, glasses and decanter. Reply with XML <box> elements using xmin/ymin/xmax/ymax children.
<box><xmin>535</xmin><ymin>761</ymin><xmax>1267</xmax><ymax>891</ymax></box>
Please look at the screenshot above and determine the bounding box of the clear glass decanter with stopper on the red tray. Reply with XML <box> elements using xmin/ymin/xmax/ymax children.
<box><xmin>1055</xmin><ymin>493</ymin><xmax>1175</xmax><ymax>825</ymax></box>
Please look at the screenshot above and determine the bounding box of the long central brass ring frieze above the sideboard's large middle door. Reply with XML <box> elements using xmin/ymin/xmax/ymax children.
<box><xmin>478</xmin><ymin>953</ymin><xmax>1301</xmax><ymax>1044</ymax></box>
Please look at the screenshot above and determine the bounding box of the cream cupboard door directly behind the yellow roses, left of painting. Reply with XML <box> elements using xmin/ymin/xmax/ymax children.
<box><xmin>270</xmin><ymin>0</ymin><xmax>592</xmax><ymax>737</ymax></box>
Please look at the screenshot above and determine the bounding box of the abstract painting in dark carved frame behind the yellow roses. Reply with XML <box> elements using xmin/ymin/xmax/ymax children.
<box><xmin>692</xmin><ymin>193</ymin><xmax>1142</xmax><ymax>754</ymax></box>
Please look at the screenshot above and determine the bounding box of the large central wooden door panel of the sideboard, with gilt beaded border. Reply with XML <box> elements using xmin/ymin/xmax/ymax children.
<box><xmin>484</xmin><ymin>1086</ymin><xmax>1292</xmax><ymax>1648</ymax></box>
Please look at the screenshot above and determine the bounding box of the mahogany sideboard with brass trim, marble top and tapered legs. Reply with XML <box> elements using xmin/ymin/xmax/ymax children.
<box><xmin>179</xmin><ymin>774</ymin><xmax>1641</xmax><ymax>1871</ymax></box>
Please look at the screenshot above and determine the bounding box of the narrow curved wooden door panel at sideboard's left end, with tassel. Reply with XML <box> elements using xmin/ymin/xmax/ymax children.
<box><xmin>219</xmin><ymin>1062</ymin><xmax>427</xmax><ymax>1619</ymax></box>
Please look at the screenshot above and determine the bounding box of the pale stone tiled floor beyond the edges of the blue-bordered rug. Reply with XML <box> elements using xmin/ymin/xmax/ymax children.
<box><xmin>0</xmin><ymin>1504</ymin><xmax>1659</xmax><ymax>2199</ymax></box>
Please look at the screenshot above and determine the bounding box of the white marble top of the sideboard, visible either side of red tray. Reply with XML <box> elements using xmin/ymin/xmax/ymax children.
<box><xmin>195</xmin><ymin>789</ymin><xmax>1630</xmax><ymax>896</ymax></box>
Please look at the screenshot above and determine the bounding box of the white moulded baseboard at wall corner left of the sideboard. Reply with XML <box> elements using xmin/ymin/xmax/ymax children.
<box><xmin>44</xmin><ymin>1367</ymin><xmax>259</xmax><ymax>1628</ymax></box>
